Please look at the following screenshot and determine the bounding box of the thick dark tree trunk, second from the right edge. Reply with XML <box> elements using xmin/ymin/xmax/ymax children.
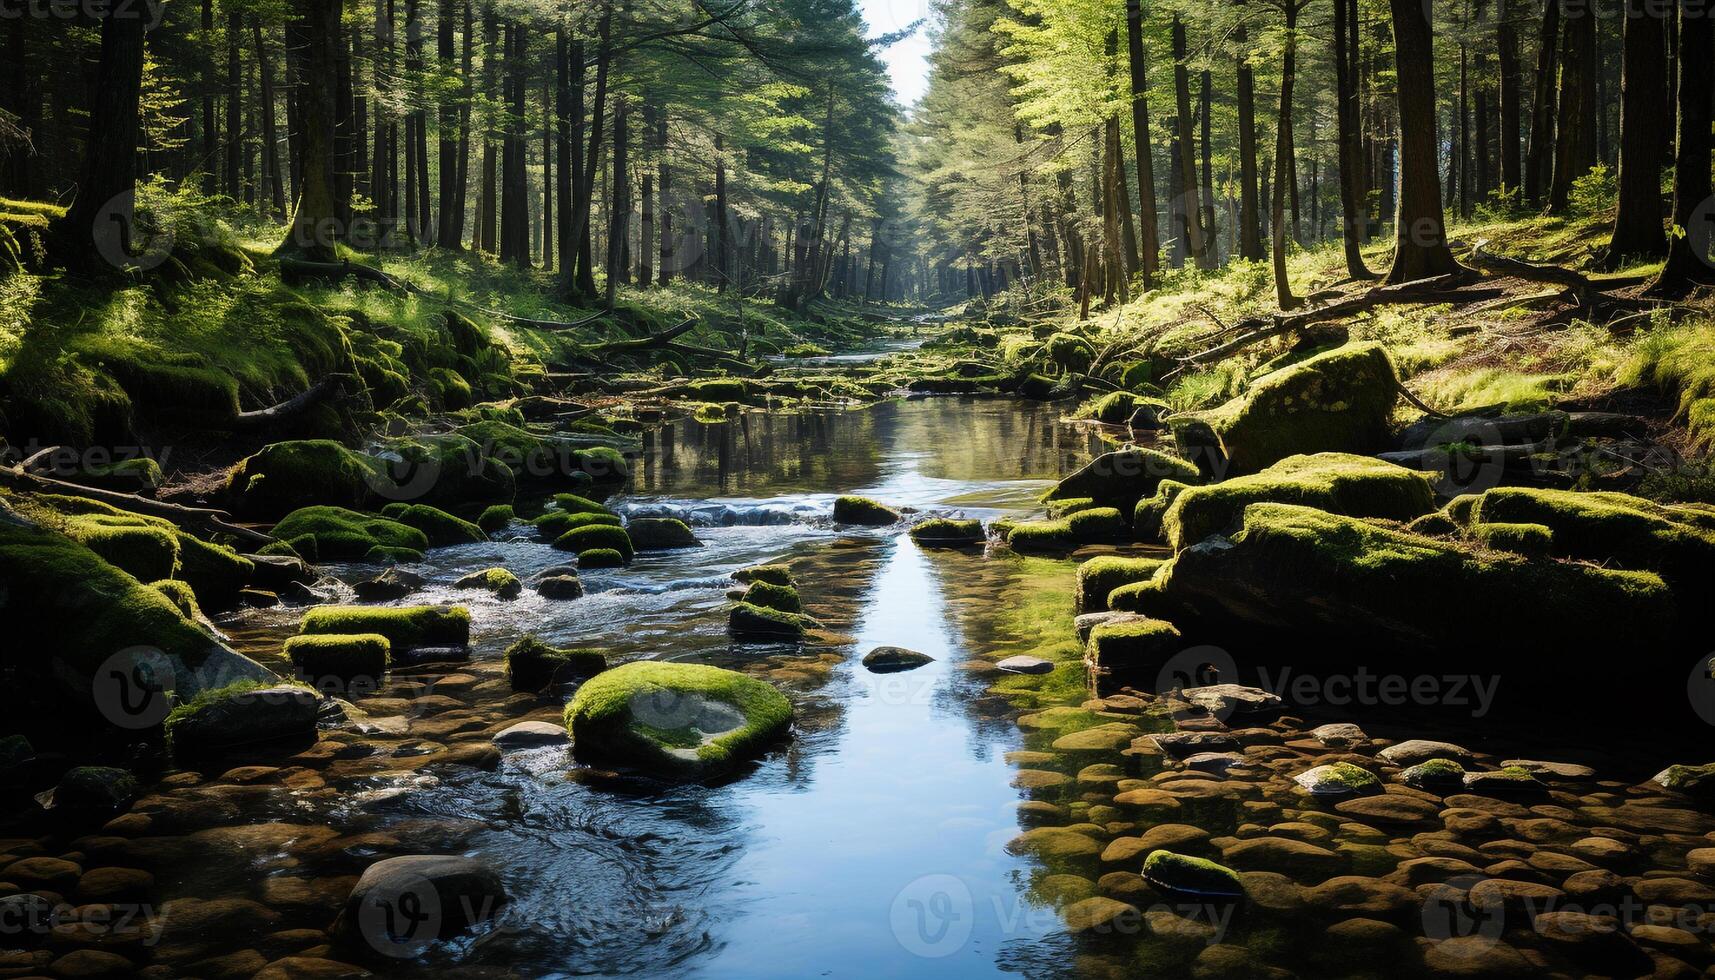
<box><xmin>1604</xmin><ymin>0</ymin><xmax>1667</xmax><ymax>269</ymax></box>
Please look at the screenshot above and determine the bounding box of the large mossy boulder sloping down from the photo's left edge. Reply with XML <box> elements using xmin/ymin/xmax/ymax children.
<box><xmin>0</xmin><ymin>505</ymin><xmax>273</xmax><ymax>707</ymax></box>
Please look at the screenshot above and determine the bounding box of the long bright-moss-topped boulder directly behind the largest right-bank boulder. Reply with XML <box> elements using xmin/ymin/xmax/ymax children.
<box><xmin>1161</xmin><ymin>453</ymin><xmax>1435</xmax><ymax>551</ymax></box>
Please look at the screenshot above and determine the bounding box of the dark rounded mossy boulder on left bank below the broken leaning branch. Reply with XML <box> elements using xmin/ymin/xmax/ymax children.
<box><xmin>225</xmin><ymin>439</ymin><xmax>396</xmax><ymax>520</ymax></box>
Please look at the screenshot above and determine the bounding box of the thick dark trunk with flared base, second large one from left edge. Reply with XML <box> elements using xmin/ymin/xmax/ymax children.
<box><xmin>280</xmin><ymin>0</ymin><xmax>341</xmax><ymax>261</ymax></box>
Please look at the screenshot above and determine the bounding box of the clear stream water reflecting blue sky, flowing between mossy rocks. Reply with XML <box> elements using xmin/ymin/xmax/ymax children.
<box><xmin>202</xmin><ymin>398</ymin><xmax>1125</xmax><ymax>977</ymax></box>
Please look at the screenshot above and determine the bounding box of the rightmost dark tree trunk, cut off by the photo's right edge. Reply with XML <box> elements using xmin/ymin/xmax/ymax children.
<box><xmin>1650</xmin><ymin>0</ymin><xmax>1715</xmax><ymax>295</ymax></box>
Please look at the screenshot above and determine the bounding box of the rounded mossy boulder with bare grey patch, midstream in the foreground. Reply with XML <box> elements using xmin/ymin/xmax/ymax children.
<box><xmin>566</xmin><ymin>661</ymin><xmax>792</xmax><ymax>777</ymax></box>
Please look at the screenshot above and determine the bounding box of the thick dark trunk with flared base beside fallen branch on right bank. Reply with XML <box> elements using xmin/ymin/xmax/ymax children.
<box><xmin>1387</xmin><ymin>0</ymin><xmax>1459</xmax><ymax>283</ymax></box>
